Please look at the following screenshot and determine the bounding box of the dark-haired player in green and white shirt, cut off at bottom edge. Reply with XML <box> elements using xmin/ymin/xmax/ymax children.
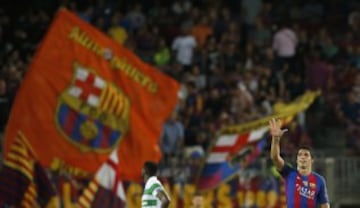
<box><xmin>141</xmin><ymin>161</ymin><xmax>170</xmax><ymax>208</ymax></box>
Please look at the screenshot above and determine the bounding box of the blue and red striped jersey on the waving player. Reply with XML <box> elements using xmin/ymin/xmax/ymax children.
<box><xmin>280</xmin><ymin>164</ymin><xmax>329</xmax><ymax>208</ymax></box>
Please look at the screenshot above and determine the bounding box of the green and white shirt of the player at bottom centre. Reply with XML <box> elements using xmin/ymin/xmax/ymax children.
<box><xmin>141</xmin><ymin>176</ymin><xmax>165</xmax><ymax>208</ymax></box>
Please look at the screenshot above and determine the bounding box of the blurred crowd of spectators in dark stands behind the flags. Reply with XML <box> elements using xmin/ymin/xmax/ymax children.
<box><xmin>0</xmin><ymin>0</ymin><xmax>360</xmax><ymax>180</ymax></box>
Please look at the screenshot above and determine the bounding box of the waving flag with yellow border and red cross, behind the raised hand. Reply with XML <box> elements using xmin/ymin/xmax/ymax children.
<box><xmin>197</xmin><ymin>91</ymin><xmax>320</xmax><ymax>190</ymax></box>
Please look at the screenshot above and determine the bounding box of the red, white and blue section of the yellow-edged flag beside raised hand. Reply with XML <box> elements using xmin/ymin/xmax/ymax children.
<box><xmin>197</xmin><ymin>127</ymin><xmax>269</xmax><ymax>190</ymax></box>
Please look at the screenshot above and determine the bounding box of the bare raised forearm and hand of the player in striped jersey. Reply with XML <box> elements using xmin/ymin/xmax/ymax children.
<box><xmin>269</xmin><ymin>118</ymin><xmax>287</xmax><ymax>171</ymax></box>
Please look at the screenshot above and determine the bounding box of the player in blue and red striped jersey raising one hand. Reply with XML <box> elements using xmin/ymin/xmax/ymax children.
<box><xmin>269</xmin><ymin>119</ymin><xmax>330</xmax><ymax>208</ymax></box>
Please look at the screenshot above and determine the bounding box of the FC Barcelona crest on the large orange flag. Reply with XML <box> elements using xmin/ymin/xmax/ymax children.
<box><xmin>55</xmin><ymin>63</ymin><xmax>130</xmax><ymax>152</ymax></box>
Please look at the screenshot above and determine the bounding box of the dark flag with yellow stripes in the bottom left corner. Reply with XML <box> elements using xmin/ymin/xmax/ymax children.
<box><xmin>0</xmin><ymin>133</ymin><xmax>59</xmax><ymax>208</ymax></box>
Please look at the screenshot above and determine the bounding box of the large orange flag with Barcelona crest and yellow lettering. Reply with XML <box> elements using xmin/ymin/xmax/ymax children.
<box><xmin>5</xmin><ymin>9</ymin><xmax>179</xmax><ymax>180</ymax></box>
